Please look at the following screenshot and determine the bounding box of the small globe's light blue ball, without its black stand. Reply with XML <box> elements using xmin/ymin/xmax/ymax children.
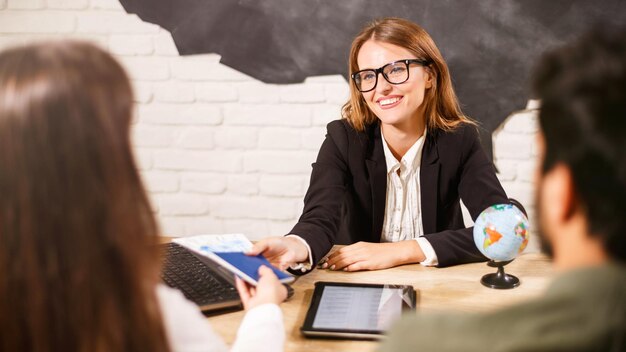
<box><xmin>474</xmin><ymin>204</ymin><xmax>529</xmax><ymax>262</ymax></box>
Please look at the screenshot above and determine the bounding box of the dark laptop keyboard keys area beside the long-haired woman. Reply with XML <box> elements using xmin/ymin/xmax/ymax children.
<box><xmin>161</xmin><ymin>243</ymin><xmax>239</xmax><ymax>310</ymax></box>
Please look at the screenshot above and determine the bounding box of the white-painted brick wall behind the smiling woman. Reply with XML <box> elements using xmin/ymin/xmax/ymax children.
<box><xmin>0</xmin><ymin>0</ymin><xmax>537</xmax><ymax>253</ymax></box>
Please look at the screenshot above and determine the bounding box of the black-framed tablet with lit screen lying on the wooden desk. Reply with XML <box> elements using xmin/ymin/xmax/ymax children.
<box><xmin>300</xmin><ymin>281</ymin><xmax>417</xmax><ymax>339</ymax></box>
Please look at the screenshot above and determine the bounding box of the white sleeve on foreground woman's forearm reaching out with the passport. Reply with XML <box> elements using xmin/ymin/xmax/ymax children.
<box><xmin>231</xmin><ymin>303</ymin><xmax>285</xmax><ymax>352</ymax></box>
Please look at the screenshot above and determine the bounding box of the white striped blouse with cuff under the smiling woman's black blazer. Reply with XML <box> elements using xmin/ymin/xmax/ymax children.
<box><xmin>380</xmin><ymin>128</ymin><xmax>438</xmax><ymax>266</ymax></box>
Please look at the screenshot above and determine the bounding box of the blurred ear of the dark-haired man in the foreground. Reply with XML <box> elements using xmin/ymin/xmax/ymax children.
<box><xmin>543</xmin><ymin>163</ymin><xmax>577</xmax><ymax>223</ymax></box>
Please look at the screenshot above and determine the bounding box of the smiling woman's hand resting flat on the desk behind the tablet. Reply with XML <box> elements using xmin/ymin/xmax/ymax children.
<box><xmin>322</xmin><ymin>240</ymin><xmax>425</xmax><ymax>271</ymax></box>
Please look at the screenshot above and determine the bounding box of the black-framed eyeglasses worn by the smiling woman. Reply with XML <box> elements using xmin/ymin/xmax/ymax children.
<box><xmin>350</xmin><ymin>59</ymin><xmax>430</xmax><ymax>93</ymax></box>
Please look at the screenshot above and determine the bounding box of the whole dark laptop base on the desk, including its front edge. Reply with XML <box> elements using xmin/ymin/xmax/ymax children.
<box><xmin>161</xmin><ymin>242</ymin><xmax>243</xmax><ymax>315</ymax></box>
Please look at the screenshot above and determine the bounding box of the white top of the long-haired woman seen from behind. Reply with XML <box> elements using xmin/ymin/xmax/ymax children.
<box><xmin>157</xmin><ymin>284</ymin><xmax>285</xmax><ymax>352</ymax></box>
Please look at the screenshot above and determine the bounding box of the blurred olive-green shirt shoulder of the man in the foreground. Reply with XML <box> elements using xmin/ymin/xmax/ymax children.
<box><xmin>381</xmin><ymin>284</ymin><xmax>621</xmax><ymax>351</ymax></box>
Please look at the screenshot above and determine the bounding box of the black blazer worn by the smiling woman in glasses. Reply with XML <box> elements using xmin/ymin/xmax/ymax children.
<box><xmin>290</xmin><ymin>120</ymin><xmax>508</xmax><ymax>267</ymax></box>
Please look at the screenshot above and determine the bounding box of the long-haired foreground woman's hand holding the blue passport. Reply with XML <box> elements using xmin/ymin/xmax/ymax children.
<box><xmin>235</xmin><ymin>265</ymin><xmax>287</xmax><ymax>310</ymax></box>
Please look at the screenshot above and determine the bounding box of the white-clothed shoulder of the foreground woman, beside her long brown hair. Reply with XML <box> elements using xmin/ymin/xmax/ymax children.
<box><xmin>157</xmin><ymin>284</ymin><xmax>228</xmax><ymax>352</ymax></box>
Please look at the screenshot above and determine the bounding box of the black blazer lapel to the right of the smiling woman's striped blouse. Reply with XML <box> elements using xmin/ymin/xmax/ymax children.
<box><xmin>420</xmin><ymin>132</ymin><xmax>440</xmax><ymax>234</ymax></box>
